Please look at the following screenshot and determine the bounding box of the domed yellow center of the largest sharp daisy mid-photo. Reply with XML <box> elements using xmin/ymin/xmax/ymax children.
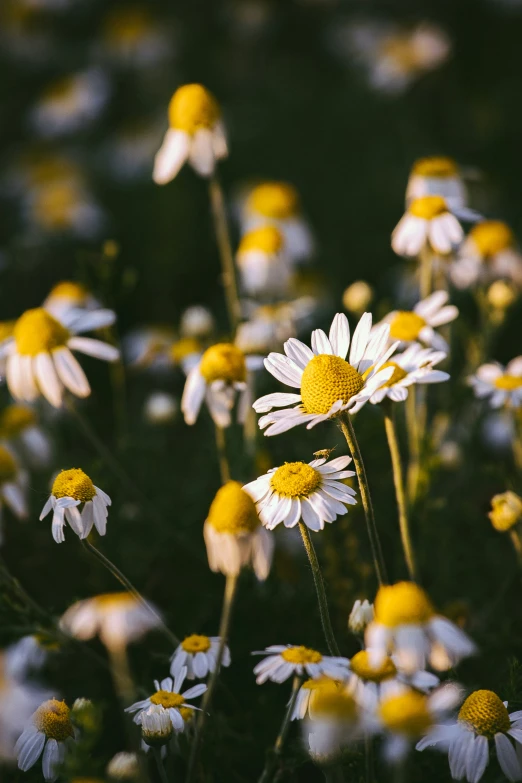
<box><xmin>301</xmin><ymin>354</ymin><xmax>364</xmax><ymax>413</ymax></box>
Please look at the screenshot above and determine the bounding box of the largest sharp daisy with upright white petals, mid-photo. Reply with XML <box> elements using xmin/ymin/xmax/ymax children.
<box><xmin>254</xmin><ymin>313</ymin><xmax>395</xmax><ymax>435</ymax></box>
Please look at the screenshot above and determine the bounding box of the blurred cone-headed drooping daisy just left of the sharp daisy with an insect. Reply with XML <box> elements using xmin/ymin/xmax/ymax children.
<box><xmin>203</xmin><ymin>481</ymin><xmax>274</xmax><ymax>580</ymax></box>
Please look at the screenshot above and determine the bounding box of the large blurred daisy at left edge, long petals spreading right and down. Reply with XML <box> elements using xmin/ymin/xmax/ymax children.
<box><xmin>2</xmin><ymin>307</ymin><xmax>119</xmax><ymax>408</ymax></box>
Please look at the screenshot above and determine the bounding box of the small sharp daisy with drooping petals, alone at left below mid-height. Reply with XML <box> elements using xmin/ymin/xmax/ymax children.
<box><xmin>40</xmin><ymin>468</ymin><xmax>111</xmax><ymax>544</ymax></box>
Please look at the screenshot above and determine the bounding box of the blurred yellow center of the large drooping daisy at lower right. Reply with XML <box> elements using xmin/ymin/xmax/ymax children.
<box><xmin>374</xmin><ymin>582</ymin><xmax>434</xmax><ymax>628</ymax></box>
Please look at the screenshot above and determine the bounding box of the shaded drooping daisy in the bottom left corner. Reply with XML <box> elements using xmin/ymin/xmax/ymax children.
<box><xmin>15</xmin><ymin>699</ymin><xmax>75</xmax><ymax>781</ymax></box>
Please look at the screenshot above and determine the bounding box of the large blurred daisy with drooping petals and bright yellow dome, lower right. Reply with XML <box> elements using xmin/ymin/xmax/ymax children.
<box><xmin>365</xmin><ymin>582</ymin><xmax>476</xmax><ymax>674</ymax></box>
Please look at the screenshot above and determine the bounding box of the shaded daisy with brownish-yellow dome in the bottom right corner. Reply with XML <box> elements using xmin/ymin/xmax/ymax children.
<box><xmin>417</xmin><ymin>690</ymin><xmax>522</xmax><ymax>783</ymax></box>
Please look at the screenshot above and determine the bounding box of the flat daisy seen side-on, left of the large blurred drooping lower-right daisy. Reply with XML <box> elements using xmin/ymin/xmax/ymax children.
<box><xmin>252</xmin><ymin>644</ymin><xmax>350</xmax><ymax>685</ymax></box>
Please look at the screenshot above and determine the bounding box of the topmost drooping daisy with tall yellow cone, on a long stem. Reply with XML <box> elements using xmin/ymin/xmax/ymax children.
<box><xmin>152</xmin><ymin>84</ymin><xmax>224</xmax><ymax>185</ymax></box>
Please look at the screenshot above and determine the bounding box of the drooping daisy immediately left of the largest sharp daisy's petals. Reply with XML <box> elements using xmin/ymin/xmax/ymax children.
<box><xmin>181</xmin><ymin>343</ymin><xmax>261</xmax><ymax>427</ymax></box>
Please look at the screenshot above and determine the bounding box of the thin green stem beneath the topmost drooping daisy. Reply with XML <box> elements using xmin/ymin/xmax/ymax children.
<box><xmin>209</xmin><ymin>174</ymin><xmax>241</xmax><ymax>338</ymax></box>
